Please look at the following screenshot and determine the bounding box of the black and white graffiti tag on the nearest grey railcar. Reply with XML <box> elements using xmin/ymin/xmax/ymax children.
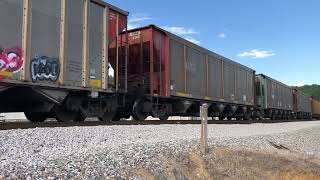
<box><xmin>30</xmin><ymin>56</ymin><xmax>60</xmax><ymax>82</ymax></box>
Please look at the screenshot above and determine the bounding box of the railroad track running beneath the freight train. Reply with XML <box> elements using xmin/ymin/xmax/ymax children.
<box><xmin>0</xmin><ymin>119</ymin><xmax>313</xmax><ymax>130</ymax></box>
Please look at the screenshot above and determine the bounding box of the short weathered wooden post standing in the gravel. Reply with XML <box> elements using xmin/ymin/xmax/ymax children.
<box><xmin>200</xmin><ymin>104</ymin><xmax>208</xmax><ymax>154</ymax></box>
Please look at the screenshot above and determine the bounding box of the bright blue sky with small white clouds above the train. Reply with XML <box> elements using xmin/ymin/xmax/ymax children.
<box><xmin>107</xmin><ymin>0</ymin><xmax>320</xmax><ymax>86</ymax></box>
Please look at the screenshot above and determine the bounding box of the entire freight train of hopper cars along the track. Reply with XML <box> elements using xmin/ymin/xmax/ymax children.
<box><xmin>0</xmin><ymin>0</ymin><xmax>320</xmax><ymax>122</ymax></box>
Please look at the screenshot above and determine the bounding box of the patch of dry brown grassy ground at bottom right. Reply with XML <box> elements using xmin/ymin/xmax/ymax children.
<box><xmin>132</xmin><ymin>149</ymin><xmax>320</xmax><ymax>180</ymax></box>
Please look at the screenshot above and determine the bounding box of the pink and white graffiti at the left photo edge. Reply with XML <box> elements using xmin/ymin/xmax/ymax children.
<box><xmin>0</xmin><ymin>47</ymin><xmax>24</xmax><ymax>80</ymax></box>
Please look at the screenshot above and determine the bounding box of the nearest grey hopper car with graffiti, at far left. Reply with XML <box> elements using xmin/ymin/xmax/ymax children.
<box><xmin>0</xmin><ymin>0</ymin><xmax>128</xmax><ymax>122</ymax></box>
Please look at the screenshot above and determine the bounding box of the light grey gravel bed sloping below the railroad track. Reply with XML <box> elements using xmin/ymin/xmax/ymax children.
<box><xmin>0</xmin><ymin>121</ymin><xmax>320</xmax><ymax>179</ymax></box>
